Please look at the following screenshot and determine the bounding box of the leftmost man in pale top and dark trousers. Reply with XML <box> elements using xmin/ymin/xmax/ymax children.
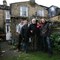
<box><xmin>16</xmin><ymin>20</ymin><xmax>24</xmax><ymax>51</ymax></box>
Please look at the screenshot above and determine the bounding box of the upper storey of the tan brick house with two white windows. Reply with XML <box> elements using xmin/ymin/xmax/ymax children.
<box><xmin>11</xmin><ymin>1</ymin><xmax>47</xmax><ymax>18</ymax></box>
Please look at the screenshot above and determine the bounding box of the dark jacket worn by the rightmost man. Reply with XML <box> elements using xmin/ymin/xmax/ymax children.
<box><xmin>40</xmin><ymin>22</ymin><xmax>51</xmax><ymax>36</ymax></box>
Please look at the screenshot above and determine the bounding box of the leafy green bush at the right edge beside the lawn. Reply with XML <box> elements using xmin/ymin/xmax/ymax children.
<box><xmin>51</xmin><ymin>32</ymin><xmax>60</xmax><ymax>51</ymax></box>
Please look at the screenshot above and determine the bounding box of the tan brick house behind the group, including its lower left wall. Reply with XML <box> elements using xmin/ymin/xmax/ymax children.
<box><xmin>10</xmin><ymin>0</ymin><xmax>48</xmax><ymax>36</ymax></box>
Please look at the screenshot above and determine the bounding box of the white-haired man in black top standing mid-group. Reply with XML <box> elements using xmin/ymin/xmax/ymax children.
<box><xmin>29</xmin><ymin>19</ymin><xmax>37</xmax><ymax>50</ymax></box>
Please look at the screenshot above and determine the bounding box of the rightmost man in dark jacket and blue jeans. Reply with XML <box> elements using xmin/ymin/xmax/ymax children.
<box><xmin>40</xmin><ymin>18</ymin><xmax>52</xmax><ymax>55</ymax></box>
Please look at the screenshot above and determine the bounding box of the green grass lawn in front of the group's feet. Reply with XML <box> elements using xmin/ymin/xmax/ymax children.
<box><xmin>17</xmin><ymin>52</ymin><xmax>60</xmax><ymax>60</ymax></box>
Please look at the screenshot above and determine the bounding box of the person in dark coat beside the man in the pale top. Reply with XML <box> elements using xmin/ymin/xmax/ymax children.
<box><xmin>21</xmin><ymin>20</ymin><xmax>29</xmax><ymax>52</ymax></box>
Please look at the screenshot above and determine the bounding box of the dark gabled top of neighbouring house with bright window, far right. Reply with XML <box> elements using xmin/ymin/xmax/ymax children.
<box><xmin>48</xmin><ymin>5</ymin><xmax>60</xmax><ymax>17</ymax></box>
